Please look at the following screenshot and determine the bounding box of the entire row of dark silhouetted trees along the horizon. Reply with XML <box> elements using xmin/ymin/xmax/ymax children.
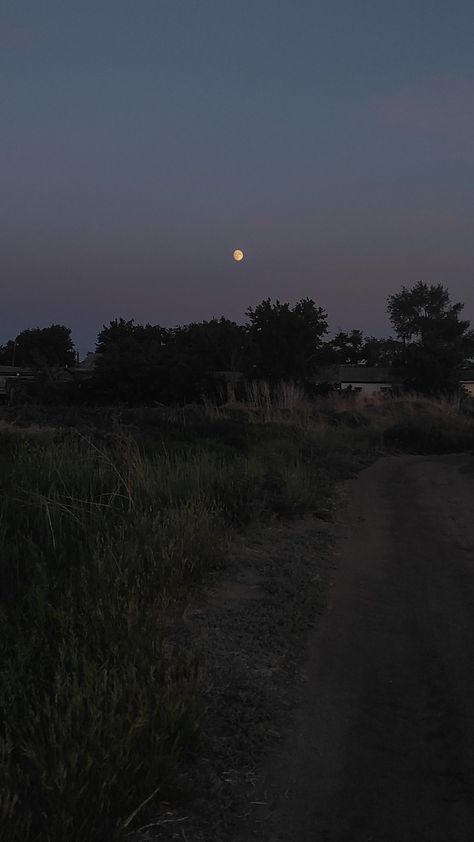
<box><xmin>0</xmin><ymin>281</ymin><xmax>474</xmax><ymax>403</ymax></box>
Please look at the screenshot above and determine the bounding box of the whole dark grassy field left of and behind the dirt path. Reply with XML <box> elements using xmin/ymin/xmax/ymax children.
<box><xmin>0</xmin><ymin>386</ymin><xmax>474</xmax><ymax>842</ymax></box>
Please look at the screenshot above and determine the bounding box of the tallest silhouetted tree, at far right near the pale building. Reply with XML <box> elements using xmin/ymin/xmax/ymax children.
<box><xmin>388</xmin><ymin>281</ymin><xmax>474</xmax><ymax>395</ymax></box>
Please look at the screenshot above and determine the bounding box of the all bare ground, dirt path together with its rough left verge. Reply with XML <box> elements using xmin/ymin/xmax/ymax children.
<box><xmin>130</xmin><ymin>454</ymin><xmax>474</xmax><ymax>842</ymax></box>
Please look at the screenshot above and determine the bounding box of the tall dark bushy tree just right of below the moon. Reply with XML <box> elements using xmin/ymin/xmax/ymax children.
<box><xmin>246</xmin><ymin>298</ymin><xmax>328</xmax><ymax>381</ymax></box>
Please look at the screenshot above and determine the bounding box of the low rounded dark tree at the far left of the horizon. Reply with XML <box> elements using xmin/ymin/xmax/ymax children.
<box><xmin>0</xmin><ymin>324</ymin><xmax>76</xmax><ymax>371</ymax></box>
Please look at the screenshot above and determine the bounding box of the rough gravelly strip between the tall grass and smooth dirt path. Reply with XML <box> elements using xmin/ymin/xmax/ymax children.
<box><xmin>130</xmin><ymin>502</ymin><xmax>334</xmax><ymax>842</ymax></box>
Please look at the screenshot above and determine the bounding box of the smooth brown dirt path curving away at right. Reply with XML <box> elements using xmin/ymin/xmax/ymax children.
<box><xmin>241</xmin><ymin>455</ymin><xmax>474</xmax><ymax>842</ymax></box>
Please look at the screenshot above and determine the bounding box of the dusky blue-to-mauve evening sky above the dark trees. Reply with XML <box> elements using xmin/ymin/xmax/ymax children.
<box><xmin>0</xmin><ymin>0</ymin><xmax>474</xmax><ymax>354</ymax></box>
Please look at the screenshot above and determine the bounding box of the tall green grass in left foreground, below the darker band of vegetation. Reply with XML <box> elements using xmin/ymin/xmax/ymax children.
<box><xmin>0</xmin><ymin>432</ymin><xmax>328</xmax><ymax>842</ymax></box>
